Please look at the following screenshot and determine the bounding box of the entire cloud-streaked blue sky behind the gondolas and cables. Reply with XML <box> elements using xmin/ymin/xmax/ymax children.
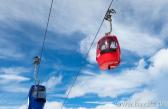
<box><xmin>0</xmin><ymin>0</ymin><xmax>168</xmax><ymax>109</ymax></box>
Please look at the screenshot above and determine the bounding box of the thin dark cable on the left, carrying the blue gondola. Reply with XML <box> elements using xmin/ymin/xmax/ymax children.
<box><xmin>36</xmin><ymin>0</ymin><xmax>54</xmax><ymax>82</ymax></box>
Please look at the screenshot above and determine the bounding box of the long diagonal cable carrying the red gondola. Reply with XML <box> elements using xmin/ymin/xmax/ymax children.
<box><xmin>61</xmin><ymin>0</ymin><xmax>114</xmax><ymax>109</ymax></box>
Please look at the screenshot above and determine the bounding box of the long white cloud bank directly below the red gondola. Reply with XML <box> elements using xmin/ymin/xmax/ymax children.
<box><xmin>70</xmin><ymin>65</ymin><xmax>149</xmax><ymax>97</ymax></box>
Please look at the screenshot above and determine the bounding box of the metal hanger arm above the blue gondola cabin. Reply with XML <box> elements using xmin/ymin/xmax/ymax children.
<box><xmin>34</xmin><ymin>56</ymin><xmax>40</xmax><ymax>85</ymax></box>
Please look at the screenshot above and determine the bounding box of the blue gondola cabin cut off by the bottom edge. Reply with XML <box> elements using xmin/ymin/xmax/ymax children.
<box><xmin>28</xmin><ymin>85</ymin><xmax>46</xmax><ymax>109</ymax></box>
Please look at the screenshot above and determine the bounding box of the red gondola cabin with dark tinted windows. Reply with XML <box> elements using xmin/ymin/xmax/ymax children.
<box><xmin>96</xmin><ymin>35</ymin><xmax>120</xmax><ymax>70</ymax></box>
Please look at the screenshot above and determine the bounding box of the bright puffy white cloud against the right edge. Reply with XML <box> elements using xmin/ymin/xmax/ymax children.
<box><xmin>149</xmin><ymin>49</ymin><xmax>168</xmax><ymax>101</ymax></box>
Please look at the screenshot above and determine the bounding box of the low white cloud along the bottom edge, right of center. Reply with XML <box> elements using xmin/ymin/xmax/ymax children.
<box><xmin>95</xmin><ymin>90</ymin><xmax>158</xmax><ymax>109</ymax></box>
